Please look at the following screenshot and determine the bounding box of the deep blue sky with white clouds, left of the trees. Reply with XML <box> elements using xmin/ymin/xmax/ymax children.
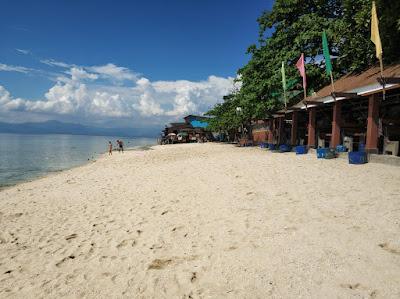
<box><xmin>0</xmin><ymin>0</ymin><xmax>272</xmax><ymax>124</ymax></box>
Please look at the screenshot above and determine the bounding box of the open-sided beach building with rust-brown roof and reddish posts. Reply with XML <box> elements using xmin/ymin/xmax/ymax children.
<box><xmin>252</xmin><ymin>64</ymin><xmax>400</xmax><ymax>156</ymax></box>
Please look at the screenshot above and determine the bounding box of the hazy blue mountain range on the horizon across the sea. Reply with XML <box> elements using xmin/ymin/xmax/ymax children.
<box><xmin>0</xmin><ymin>120</ymin><xmax>161</xmax><ymax>137</ymax></box>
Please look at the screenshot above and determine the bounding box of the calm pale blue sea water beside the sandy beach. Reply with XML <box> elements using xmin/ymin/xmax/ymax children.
<box><xmin>0</xmin><ymin>133</ymin><xmax>156</xmax><ymax>186</ymax></box>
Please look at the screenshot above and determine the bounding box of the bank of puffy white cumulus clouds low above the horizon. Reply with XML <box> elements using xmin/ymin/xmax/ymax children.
<box><xmin>0</xmin><ymin>60</ymin><xmax>237</xmax><ymax>125</ymax></box>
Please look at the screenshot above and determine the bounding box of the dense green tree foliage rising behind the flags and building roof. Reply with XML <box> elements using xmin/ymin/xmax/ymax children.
<box><xmin>210</xmin><ymin>0</ymin><xmax>400</xmax><ymax>132</ymax></box>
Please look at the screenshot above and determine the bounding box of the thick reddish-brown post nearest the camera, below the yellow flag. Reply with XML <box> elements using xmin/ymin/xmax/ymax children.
<box><xmin>366</xmin><ymin>94</ymin><xmax>380</xmax><ymax>153</ymax></box>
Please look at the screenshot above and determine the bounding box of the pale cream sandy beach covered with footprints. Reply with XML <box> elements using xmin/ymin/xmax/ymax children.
<box><xmin>0</xmin><ymin>144</ymin><xmax>400</xmax><ymax>298</ymax></box>
